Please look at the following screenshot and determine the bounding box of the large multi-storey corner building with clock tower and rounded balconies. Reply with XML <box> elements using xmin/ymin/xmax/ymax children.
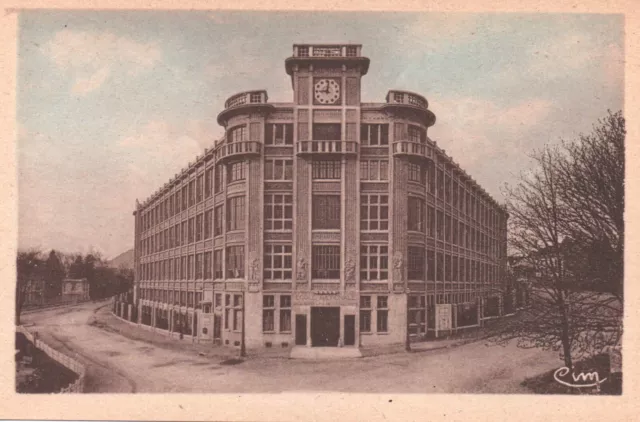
<box><xmin>127</xmin><ymin>44</ymin><xmax>514</xmax><ymax>348</ymax></box>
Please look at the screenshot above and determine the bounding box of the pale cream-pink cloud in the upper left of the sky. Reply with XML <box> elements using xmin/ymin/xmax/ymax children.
<box><xmin>43</xmin><ymin>29</ymin><xmax>162</xmax><ymax>95</ymax></box>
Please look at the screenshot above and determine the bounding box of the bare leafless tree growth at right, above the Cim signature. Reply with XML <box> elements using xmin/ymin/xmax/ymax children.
<box><xmin>494</xmin><ymin>113</ymin><xmax>624</xmax><ymax>367</ymax></box>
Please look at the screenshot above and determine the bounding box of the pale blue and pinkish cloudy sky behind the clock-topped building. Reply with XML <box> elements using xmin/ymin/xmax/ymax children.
<box><xmin>17</xmin><ymin>10</ymin><xmax>624</xmax><ymax>258</ymax></box>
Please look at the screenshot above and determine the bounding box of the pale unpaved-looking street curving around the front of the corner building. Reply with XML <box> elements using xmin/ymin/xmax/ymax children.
<box><xmin>22</xmin><ymin>302</ymin><xmax>562</xmax><ymax>393</ymax></box>
